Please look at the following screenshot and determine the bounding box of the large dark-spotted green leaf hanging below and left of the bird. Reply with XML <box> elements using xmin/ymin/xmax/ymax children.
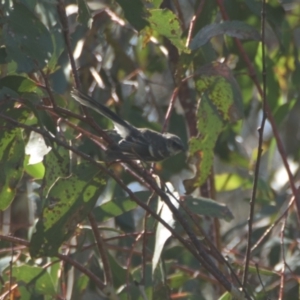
<box><xmin>29</xmin><ymin>163</ymin><xmax>106</xmax><ymax>257</ymax></box>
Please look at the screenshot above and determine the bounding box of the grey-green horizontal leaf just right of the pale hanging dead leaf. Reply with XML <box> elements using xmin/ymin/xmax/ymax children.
<box><xmin>184</xmin><ymin>196</ymin><xmax>234</xmax><ymax>222</ymax></box>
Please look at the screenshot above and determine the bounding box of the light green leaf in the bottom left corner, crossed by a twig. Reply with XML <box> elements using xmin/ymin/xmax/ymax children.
<box><xmin>12</xmin><ymin>265</ymin><xmax>57</xmax><ymax>296</ymax></box>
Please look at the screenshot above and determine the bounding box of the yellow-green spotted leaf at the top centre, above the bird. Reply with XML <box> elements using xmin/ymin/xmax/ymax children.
<box><xmin>147</xmin><ymin>9</ymin><xmax>189</xmax><ymax>52</ymax></box>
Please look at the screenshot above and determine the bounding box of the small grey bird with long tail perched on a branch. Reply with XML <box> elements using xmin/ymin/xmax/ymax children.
<box><xmin>71</xmin><ymin>89</ymin><xmax>185</xmax><ymax>162</ymax></box>
